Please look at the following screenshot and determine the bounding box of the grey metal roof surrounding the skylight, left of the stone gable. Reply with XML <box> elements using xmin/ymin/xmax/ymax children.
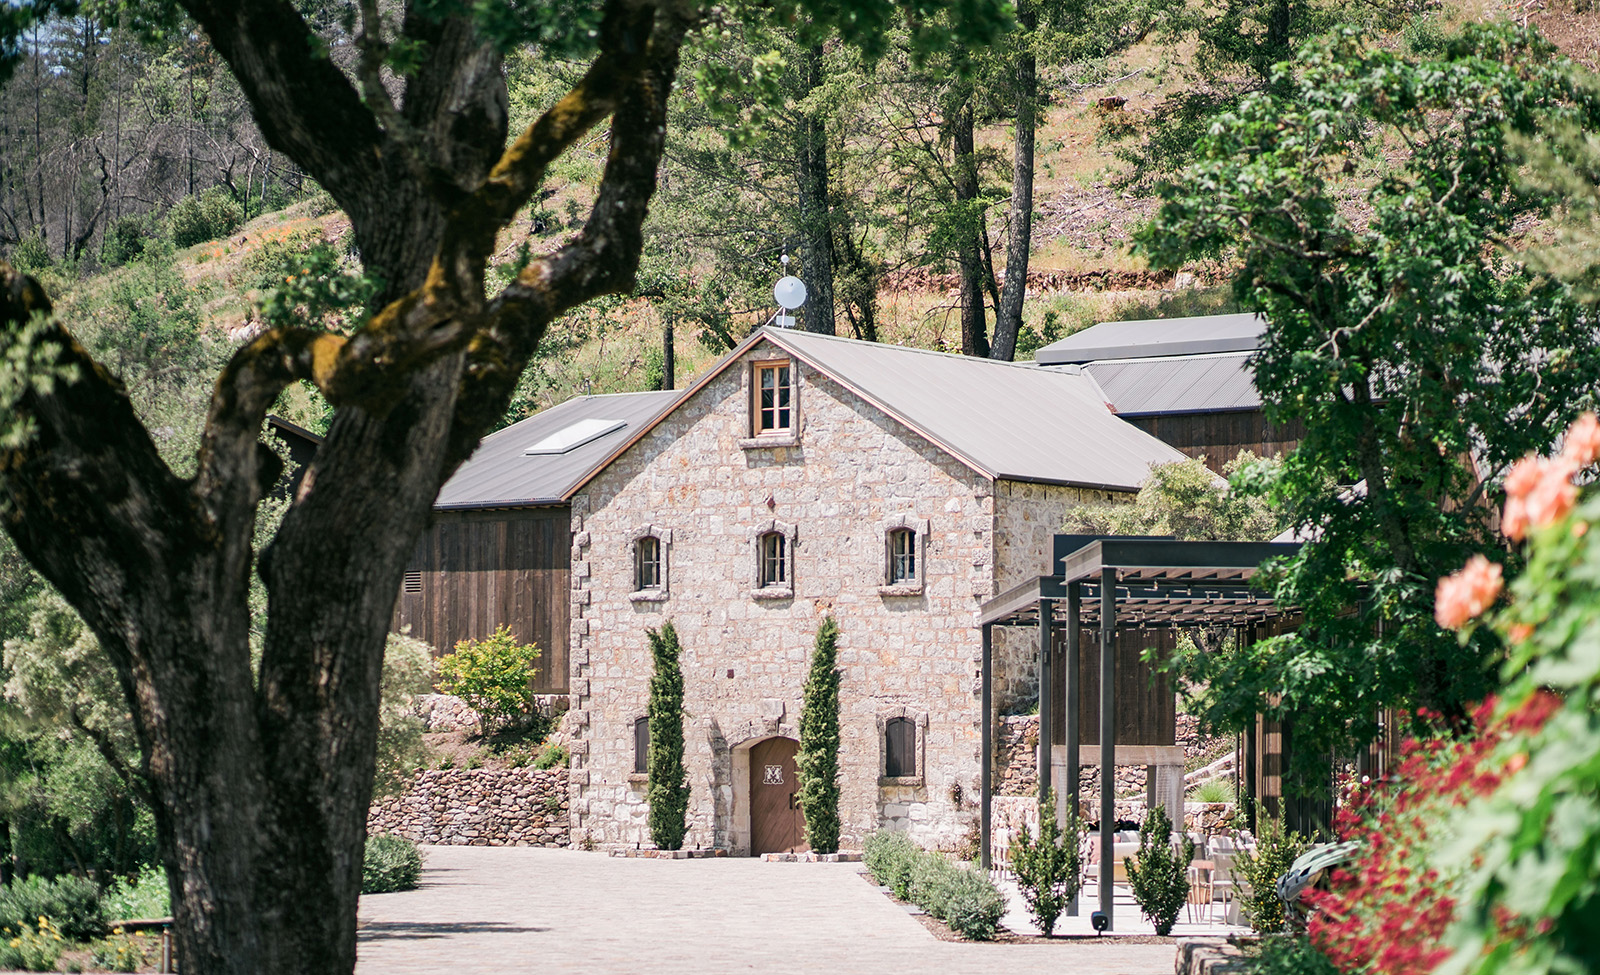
<box><xmin>434</xmin><ymin>389</ymin><xmax>682</xmax><ymax>509</ymax></box>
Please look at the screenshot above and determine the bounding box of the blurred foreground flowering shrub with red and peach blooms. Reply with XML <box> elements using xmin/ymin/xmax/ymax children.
<box><xmin>1310</xmin><ymin>415</ymin><xmax>1600</xmax><ymax>975</ymax></box>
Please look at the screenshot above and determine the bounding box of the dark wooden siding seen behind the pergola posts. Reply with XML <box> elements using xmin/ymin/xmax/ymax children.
<box><xmin>1050</xmin><ymin>628</ymin><xmax>1178</xmax><ymax>744</ymax></box>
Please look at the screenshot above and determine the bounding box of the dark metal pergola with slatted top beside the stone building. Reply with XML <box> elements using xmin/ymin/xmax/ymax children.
<box><xmin>978</xmin><ymin>535</ymin><xmax>1299</xmax><ymax>930</ymax></box>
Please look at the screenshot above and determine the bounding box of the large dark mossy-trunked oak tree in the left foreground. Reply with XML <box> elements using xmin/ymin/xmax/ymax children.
<box><xmin>0</xmin><ymin>0</ymin><xmax>1005</xmax><ymax>975</ymax></box>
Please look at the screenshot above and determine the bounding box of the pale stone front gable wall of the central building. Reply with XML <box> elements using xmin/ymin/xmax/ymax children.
<box><xmin>571</xmin><ymin>343</ymin><xmax>994</xmax><ymax>853</ymax></box>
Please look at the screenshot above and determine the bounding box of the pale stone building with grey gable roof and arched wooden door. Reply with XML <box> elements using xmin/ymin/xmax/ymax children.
<box><xmin>566</xmin><ymin>330</ymin><xmax>1182</xmax><ymax>855</ymax></box>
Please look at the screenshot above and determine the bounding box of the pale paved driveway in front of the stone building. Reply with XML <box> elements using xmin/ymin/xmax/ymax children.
<box><xmin>355</xmin><ymin>847</ymin><xmax>1173</xmax><ymax>975</ymax></box>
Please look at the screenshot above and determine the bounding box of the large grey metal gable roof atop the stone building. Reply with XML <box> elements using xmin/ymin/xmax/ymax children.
<box><xmin>576</xmin><ymin>328</ymin><xmax>1184</xmax><ymax>492</ymax></box>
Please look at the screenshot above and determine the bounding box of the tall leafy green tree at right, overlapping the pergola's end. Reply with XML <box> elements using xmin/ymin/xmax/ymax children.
<box><xmin>1138</xmin><ymin>26</ymin><xmax>1600</xmax><ymax>768</ymax></box>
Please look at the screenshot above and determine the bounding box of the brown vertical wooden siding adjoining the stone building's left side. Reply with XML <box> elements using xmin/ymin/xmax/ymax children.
<box><xmin>394</xmin><ymin>508</ymin><xmax>571</xmax><ymax>693</ymax></box>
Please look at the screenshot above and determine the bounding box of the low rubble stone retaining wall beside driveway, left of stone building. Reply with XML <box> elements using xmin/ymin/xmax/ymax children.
<box><xmin>366</xmin><ymin>768</ymin><xmax>571</xmax><ymax>847</ymax></box>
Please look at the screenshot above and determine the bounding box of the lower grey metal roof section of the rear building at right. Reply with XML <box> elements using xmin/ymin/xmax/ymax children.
<box><xmin>1082</xmin><ymin>352</ymin><xmax>1261</xmax><ymax>416</ymax></box>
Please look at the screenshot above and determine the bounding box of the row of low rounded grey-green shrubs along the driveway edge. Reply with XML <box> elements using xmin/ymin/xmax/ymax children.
<box><xmin>861</xmin><ymin>829</ymin><xmax>1005</xmax><ymax>941</ymax></box>
